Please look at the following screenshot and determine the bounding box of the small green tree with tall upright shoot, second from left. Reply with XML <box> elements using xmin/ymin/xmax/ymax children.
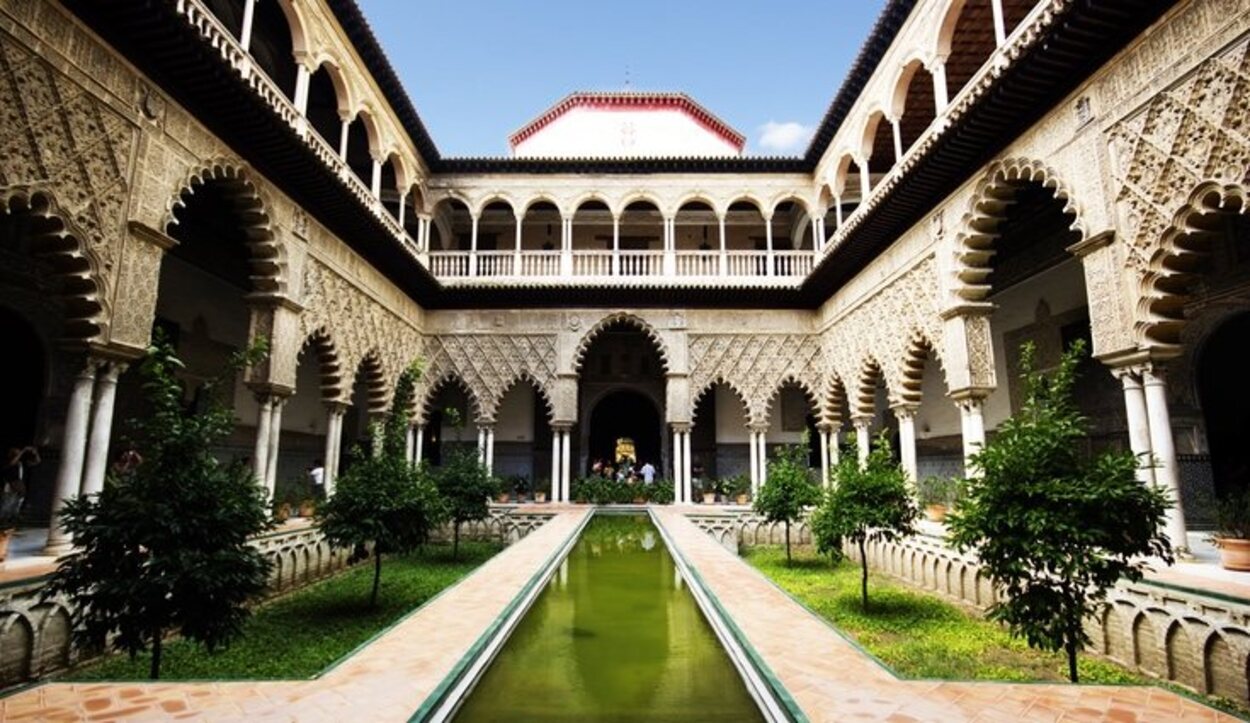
<box><xmin>316</xmin><ymin>367</ymin><xmax>446</xmax><ymax>605</ymax></box>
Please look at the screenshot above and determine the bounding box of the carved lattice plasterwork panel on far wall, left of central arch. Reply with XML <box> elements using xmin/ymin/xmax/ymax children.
<box><xmin>418</xmin><ymin>334</ymin><xmax>556</xmax><ymax>424</ymax></box>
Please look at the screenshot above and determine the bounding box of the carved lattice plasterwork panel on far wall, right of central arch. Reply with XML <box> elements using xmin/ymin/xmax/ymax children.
<box><xmin>690</xmin><ymin>334</ymin><xmax>825</xmax><ymax>425</ymax></box>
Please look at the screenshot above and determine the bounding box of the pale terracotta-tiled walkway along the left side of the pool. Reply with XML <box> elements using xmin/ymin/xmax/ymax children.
<box><xmin>0</xmin><ymin>507</ymin><xmax>590</xmax><ymax>722</ymax></box>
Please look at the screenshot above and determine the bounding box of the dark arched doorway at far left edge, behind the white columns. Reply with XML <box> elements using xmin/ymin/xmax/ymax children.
<box><xmin>0</xmin><ymin>306</ymin><xmax>46</xmax><ymax>450</ymax></box>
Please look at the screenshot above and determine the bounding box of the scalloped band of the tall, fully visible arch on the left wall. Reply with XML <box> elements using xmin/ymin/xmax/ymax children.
<box><xmin>161</xmin><ymin>159</ymin><xmax>288</xmax><ymax>295</ymax></box>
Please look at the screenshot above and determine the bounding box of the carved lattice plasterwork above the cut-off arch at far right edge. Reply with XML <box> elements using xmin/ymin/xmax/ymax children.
<box><xmin>1108</xmin><ymin>40</ymin><xmax>1250</xmax><ymax>346</ymax></box>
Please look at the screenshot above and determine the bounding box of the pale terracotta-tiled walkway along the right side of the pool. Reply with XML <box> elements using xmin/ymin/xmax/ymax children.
<box><xmin>656</xmin><ymin>508</ymin><xmax>1235</xmax><ymax>723</ymax></box>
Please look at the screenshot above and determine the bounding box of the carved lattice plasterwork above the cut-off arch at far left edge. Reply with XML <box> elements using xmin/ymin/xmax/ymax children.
<box><xmin>0</xmin><ymin>29</ymin><xmax>139</xmax><ymax>338</ymax></box>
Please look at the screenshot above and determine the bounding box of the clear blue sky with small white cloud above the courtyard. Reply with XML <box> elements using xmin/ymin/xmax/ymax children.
<box><xmin>358</xmin><ymin>0</ymin><xmax>885</xmax><ymax>156</ymax></box>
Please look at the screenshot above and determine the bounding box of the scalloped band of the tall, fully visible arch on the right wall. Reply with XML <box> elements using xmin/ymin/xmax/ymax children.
<box><xmin>955</xmin><ymin>158</ymin><xmax>1088</xmax><ymax>301</ymax></box>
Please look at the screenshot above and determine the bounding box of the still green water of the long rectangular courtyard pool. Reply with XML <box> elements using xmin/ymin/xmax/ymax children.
<box><xmin>456</xmin><ymin>515</ymin><xmax>763</xmax><ymax>720</ymax></box>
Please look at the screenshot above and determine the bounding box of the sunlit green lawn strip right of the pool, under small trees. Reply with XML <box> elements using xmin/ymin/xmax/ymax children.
<box><xmin>744</xmin><ymin>545</ymin><xmax>1248</xmax><ymax>715</ymax></box>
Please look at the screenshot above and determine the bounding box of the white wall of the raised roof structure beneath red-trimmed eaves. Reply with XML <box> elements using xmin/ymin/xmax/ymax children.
<box><xmin>513</xmin><ymin>108</ymin><xmax>739</xmax><ymax>158</ymax></box>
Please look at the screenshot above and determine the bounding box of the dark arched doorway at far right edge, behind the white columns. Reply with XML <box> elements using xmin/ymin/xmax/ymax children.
<box><xmin>1198</xmin><ymin>313</ymin><xmax>1250</xmax><ymax>498</ymax></box>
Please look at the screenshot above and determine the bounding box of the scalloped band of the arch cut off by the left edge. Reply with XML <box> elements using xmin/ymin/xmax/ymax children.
<box><xmin>0</xmin><ymin>188</ymin><xmax>109</xmax><ymax>341</ymax></box>
